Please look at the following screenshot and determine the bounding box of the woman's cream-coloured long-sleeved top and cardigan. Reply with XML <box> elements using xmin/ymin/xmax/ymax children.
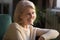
<box><xmin>3</xmin><ymin>23</ymin><xmax>59</xmax><ymax>40</ymax></box>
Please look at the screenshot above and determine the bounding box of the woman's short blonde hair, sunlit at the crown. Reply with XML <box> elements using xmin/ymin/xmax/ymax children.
<box><xmin>13</xmin><ymin>0</ymin><xmax>35</xmax><ymax>23</ymax></box>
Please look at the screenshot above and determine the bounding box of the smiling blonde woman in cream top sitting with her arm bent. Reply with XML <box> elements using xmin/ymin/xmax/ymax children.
<box><xmin>3</xmin><ymin>1</ymin><xmax>59</xmax><ymax>40</ymax></box>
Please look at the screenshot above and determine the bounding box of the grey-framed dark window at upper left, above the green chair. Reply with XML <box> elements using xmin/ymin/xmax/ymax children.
<box><xmin>0</xmin><ymin>0</ymin><xmax>13</xmax><ymax>15</ymax></box>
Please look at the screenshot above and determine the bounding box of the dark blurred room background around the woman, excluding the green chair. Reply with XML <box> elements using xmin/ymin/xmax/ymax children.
<box><xmin>0</xmin><ymin>0</ymin><xmax>60</xmax><ymax>40</ymax></box>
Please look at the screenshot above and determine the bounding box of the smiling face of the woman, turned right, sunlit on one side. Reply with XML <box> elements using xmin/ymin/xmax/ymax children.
<box><xmin>20</xmin><ymin>7</ymin><xmax>36</xmax><ymax>25</ymax></box>
